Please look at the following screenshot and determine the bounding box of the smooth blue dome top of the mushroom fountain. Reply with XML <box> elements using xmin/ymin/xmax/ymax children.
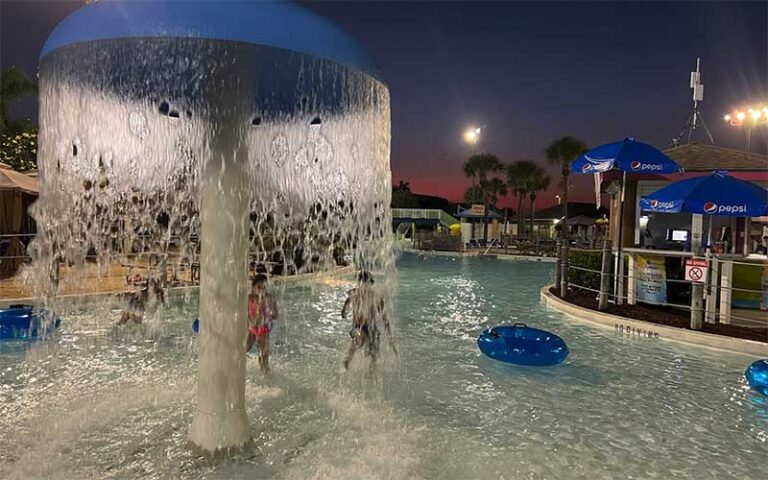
<box><xmin>40</xmin><ymin>0</ymin><xmax>384</xmax><ymax>82</ymax></box>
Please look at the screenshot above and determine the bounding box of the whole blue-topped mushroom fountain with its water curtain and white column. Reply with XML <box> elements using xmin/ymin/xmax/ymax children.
<box><xmin>33</xmin><ymin>0</ymin><xmax>391</xmax><ymax>451</ymax></box>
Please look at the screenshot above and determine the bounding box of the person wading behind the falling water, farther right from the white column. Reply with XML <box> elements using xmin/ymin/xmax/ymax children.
<box><xmin>341</xmin><ymin>271</ymin><xmax>397</xmax><ymax>369</ymax></box>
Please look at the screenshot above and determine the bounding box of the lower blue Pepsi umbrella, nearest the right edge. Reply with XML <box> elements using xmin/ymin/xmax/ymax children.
<box><xmin>640</xmin><ymin>171</ymin><xmax>768</xmax><ymax>217</ymax></box>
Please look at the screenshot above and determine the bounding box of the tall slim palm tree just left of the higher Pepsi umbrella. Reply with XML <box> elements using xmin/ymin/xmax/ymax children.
<box><xmin>544</xmin><ymin>135</ymin><xmax>587</xmax><ymax>297</ymax></box>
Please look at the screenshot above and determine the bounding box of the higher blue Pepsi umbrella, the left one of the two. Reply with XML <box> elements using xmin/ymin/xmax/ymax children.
<box><xmin>571</xmin><ymin>138</ymin><xmax>681</xmax><ymax>173</ymax></box>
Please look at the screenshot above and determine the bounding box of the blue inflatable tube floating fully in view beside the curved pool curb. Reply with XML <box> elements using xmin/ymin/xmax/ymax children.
<box><xmin>477</xmin><ymin>323</ymin><xmax>568</xmax><ymax>367</ymax></box>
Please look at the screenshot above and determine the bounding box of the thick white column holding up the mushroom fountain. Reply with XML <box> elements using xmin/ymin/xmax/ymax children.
<box><xmin>189</xmin><ymin>113</ymin><xmax>251</xmax><ymax>452</ymax></box>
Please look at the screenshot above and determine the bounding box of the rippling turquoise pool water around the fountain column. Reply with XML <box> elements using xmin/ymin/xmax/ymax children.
<box><xmin>0</xmin><ymin>255</ymin><xmax>768</xmax><ymax>479</ymax></box>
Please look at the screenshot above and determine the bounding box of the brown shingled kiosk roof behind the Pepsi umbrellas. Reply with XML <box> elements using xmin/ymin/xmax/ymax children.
<box><xmin>664</xmin><ymin>143</ymin><xmax>768</xmax><ymax>172</ymax></box>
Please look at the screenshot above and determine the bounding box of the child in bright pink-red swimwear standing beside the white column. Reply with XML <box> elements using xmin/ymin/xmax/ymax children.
<box><xmin>246</xmin><ymin>273</ymin><xmax>277</xmax><ymax>373</ymax></box>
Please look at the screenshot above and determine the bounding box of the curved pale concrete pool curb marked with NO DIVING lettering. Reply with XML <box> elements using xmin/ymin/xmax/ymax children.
<box><xmin>541</xmin><ymin>285</ymin><xmax>768</xmax><ymax>358</ymax></box>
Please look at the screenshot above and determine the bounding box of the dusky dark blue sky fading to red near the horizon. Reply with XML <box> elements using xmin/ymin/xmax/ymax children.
<box><xmin>0</xmin><ymin>0</ymin><xmax>768</xmax><ymax>207</ymax></box>
